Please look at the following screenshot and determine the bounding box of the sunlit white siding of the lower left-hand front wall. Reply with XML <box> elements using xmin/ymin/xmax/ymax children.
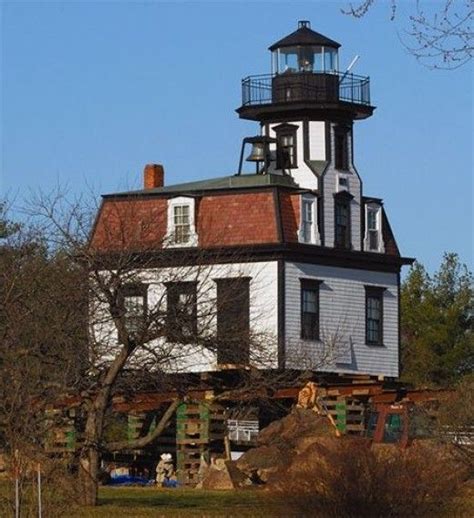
<box><xmin>92</xmin><ymin>261</ymin><xmax>278</xmax><ymax>372</ymax></box>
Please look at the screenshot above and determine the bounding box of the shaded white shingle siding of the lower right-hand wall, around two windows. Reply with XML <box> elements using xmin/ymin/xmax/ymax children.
<box><xmin>285</xmin><ymin>262</ymin><xmax>398</xmax><ymax>377</ymax></box>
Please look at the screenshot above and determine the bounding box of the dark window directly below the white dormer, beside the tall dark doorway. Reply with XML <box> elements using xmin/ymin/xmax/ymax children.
<box><xmin>166</xmin><ymin>282</ymin><xmax>197</xmax><ymax>343</ymax></box>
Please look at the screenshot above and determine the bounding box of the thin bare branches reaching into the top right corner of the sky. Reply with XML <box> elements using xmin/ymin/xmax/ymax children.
<box><xmin>342</xmin><ymin>0</ymin><xmax>474</xmax><ymax>69</ymax></box>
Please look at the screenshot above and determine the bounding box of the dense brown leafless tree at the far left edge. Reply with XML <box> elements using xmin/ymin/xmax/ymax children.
<box><xmin>0</xmin><ymin>209</ymin><xmax>87</xmax><ymax>516</ymax></box>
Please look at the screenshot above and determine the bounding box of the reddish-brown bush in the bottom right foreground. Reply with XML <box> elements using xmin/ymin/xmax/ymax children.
<box><xmin>269</xmin><ymin>438</ymin><xmax>465</xmax><ymax>518</ymax></box>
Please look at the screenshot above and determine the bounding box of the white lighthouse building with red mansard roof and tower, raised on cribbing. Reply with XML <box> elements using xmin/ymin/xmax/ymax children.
<box><xmin>90</xmin><ymin>21</ymin><xmax>412</xmax><ymax>378</ymax></box>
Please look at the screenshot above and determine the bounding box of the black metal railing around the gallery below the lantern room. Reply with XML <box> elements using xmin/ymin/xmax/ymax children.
<box><xmin>242</xmin><ymin>72</ymin><xmax>370</xmax><ymax>106</ymax></box>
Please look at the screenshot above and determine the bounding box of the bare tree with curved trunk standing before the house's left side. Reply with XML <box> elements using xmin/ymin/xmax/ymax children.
<box><xmin>16</xmin><ymin>192</ymin><xmax>286</xmax><ymax>505</ymax></box>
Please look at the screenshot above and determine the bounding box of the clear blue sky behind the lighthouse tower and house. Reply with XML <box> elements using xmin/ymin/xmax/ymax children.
<box><xmin>0</xmin><ymin>1</ymin><xmax>473</xmax><ymax>270</ymax></box>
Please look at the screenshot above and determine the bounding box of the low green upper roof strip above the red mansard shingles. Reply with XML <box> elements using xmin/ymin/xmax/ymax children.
<box><xmin>103</xmin><ymin>174</ymin><xmax>299</xmax><ymax>198</ymax></box>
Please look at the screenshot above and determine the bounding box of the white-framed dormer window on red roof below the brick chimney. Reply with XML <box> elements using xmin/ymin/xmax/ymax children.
<box><xmin>166</xmin><ymin>196</ymin><xmax>197</xmax><ymax>247</ymax></box>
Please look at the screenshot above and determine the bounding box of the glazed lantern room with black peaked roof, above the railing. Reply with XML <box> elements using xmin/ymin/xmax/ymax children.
<box><xmin>269</xmin><ymin>21</ymin><xmax>340</xmax><ymax>74</ymax></box>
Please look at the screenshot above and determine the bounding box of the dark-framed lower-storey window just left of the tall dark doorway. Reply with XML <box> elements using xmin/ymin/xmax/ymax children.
<box><xmin>165</xmin><ymin>281</ymin><xmax>198</xmax><ymax>344</ymax></box>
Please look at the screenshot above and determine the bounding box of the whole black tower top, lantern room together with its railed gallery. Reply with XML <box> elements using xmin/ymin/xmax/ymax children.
<box><xmin>237</xmin><ymin>20</ymin><xmax>374</xmax><ymax>121</ymax></box>
